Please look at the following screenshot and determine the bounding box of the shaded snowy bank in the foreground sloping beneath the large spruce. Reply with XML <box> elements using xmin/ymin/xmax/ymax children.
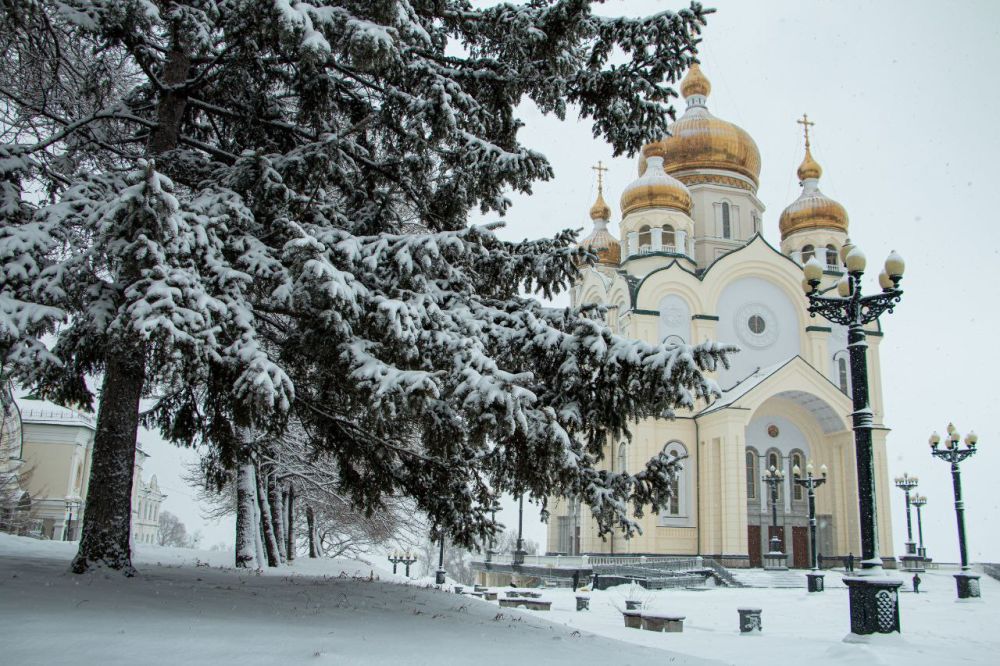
<box><xmin>0</xmin><ymin>534</ymin><xmax>717</xmax><ymax>666</ymax></box>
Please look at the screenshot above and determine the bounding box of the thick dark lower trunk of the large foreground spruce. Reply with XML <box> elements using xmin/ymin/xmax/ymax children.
<box><xmin>71</xmin><ymin>338</ymin><xmax>146</xmax><ymax>576</ymax></box>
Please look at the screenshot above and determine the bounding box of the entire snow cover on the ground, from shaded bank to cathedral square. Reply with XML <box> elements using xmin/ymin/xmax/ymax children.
<box><xmin>0</xmin><ymin>534</ymin><xmax>1000</xmax><ymax>666</ymax></box>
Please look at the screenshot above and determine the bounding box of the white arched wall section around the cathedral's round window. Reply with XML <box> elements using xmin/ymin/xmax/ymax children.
<box><xmin>716</xmin><ymin>277</ymin><xmax>801</xmax><ymax>388</ymax></box>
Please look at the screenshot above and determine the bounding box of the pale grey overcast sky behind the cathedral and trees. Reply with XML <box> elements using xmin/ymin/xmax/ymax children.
<box><xmin>146</xmin><ymin>0</ymin><xmax>1000</xmax><ymax>562</ymax></box>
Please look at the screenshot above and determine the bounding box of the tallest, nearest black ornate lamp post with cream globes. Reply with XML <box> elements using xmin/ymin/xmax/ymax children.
<box><xmin>803</xmin><ymin>240</ymin><xmax>905</xmax><ymax>635</ymax></box>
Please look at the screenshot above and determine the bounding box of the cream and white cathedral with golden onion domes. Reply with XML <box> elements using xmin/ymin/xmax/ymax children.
<box><xmin>547</xmin><ymin>65</ymin><xmax>894</xmax><ymax>568</ymax></box>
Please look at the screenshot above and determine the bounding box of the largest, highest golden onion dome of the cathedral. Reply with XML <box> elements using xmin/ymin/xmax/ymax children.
<box><xmin>639</xmin><ymin>63</ymin><xmax>760</xmax><ymax>191</ymax></box>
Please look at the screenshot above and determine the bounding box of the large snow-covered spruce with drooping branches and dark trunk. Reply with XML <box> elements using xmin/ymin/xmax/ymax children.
<box><xmin>0</xmin><ymin>0</ymin><xmax>725</xmax><ymax>571</ymax></box>
